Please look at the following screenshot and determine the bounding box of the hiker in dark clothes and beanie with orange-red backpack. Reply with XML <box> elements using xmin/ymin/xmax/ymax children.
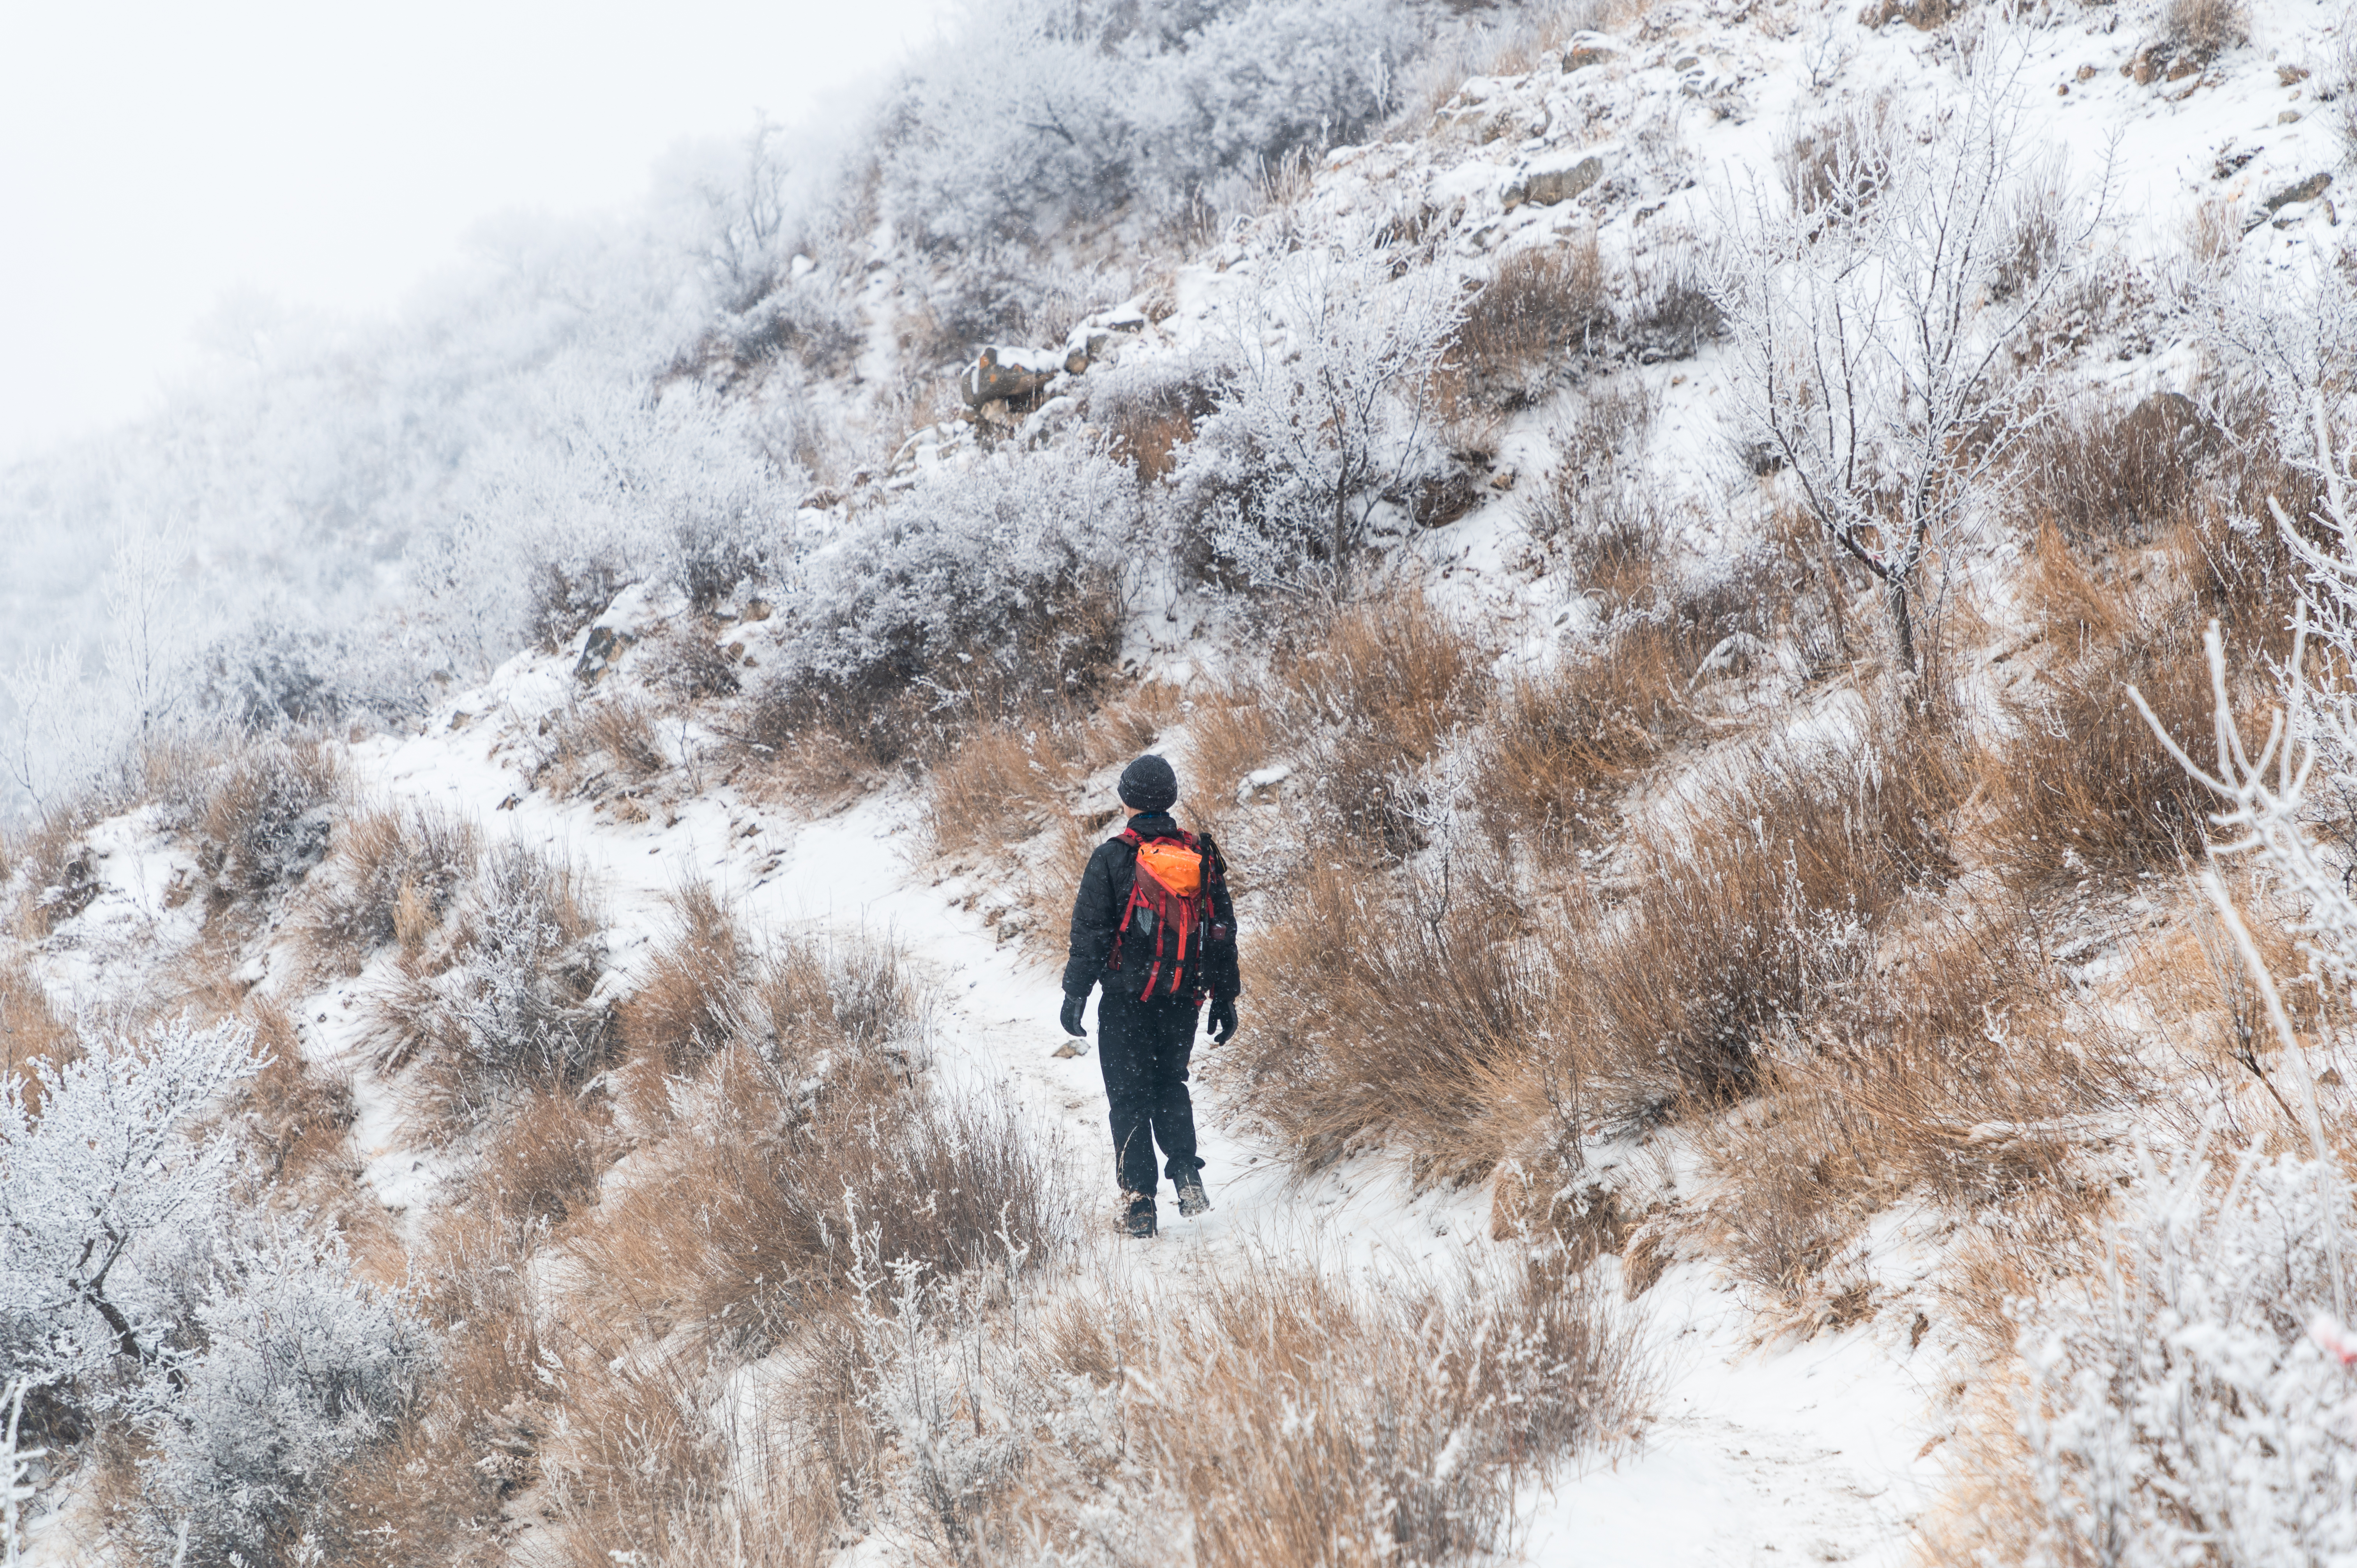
<box><xmin>1063</xmin><ymin>754</ymin><xmax>1237</xmax><ymax>1238</ymax></box>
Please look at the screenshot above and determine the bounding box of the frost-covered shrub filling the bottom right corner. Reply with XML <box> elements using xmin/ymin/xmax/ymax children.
<box><xmin>2020</xmin><ymin>1155</ymin><xmax>2357</xmax><ymax>1568</ymax></box>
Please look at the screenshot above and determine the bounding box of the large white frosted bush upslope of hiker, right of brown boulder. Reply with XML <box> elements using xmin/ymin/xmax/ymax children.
<box><xmin>1174</xmin><ymin>222</ymin><xmax>1464</xmax><ymax>585</ymax></box>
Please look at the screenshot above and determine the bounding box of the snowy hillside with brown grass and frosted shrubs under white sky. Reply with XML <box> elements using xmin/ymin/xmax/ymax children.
<box><xmin>14</xmin><ymin>0</ymin><xmax>2357</xmax><ymax>1568</ymax></box>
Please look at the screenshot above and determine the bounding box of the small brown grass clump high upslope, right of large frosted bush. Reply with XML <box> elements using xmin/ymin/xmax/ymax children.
<box><xmin>1442</xmin><ymin>233</ymin><xmax>1612</xmax><ymax>410</ymax></box>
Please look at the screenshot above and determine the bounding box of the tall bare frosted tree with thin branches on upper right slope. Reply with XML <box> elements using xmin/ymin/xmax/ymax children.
<box><xmin>1711</xmin><ymin>40</ymin><xmax>2100</xmax><ymax>672</ymax></box>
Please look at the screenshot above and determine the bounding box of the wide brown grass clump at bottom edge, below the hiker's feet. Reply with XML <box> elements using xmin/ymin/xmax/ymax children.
<box><xmin>1042</xmin><ymin>1252</ymin><xmax>1650</xmax><ymax>1568</ymax></box>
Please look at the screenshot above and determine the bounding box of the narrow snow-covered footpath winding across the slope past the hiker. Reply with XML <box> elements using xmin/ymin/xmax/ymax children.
<box><xmin>306</xmin><ymin>665</ymin><xmax>1945</xmax><ymax>1568</ymax></box>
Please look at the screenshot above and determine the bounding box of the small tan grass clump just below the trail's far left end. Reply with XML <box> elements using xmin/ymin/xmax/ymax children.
<box><xmin>295</xmin><ymin>802</ymin><xmax>481</xmax><ymax>976</ymax></box>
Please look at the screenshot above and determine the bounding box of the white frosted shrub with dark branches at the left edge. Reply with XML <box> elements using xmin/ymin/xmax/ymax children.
<box><xmin>0</xmin><ymin>1019</ymin><xmax>261</xmax><ymax>1391</ymax></box>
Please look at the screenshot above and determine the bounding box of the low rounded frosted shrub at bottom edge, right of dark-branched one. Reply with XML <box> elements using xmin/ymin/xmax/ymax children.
<box><xmin>139</xmin><ymin>1221</ymin><xmax>431</xmax><ymax>1568</ymax></box>
